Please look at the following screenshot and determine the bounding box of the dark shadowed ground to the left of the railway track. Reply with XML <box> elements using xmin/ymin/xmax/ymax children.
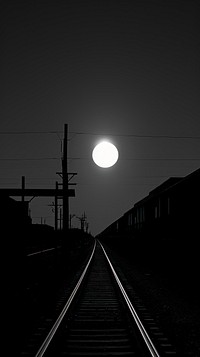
<box><xmin>6</xmin><ymin>230</ymin><xmax>93</xmax><ymax>356</ymax></box>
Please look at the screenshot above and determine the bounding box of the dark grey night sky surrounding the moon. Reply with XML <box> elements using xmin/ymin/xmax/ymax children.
<box><xmin>0</xmin><ymin>0</ymin><xmax>200</xmax><ymax>234</ymax></box>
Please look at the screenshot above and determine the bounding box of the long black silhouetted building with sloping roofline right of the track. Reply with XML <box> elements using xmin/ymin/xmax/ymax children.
<box><xmin>100</xmin><ymin>169</ymin><xmax>200</xmax><ymax>240</ymax></box>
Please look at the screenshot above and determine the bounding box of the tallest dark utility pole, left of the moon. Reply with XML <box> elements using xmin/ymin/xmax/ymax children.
<box><xmin>62</xmin><ymin>124</ymin><xmax>69</xmax><ymax>232</ymax></box>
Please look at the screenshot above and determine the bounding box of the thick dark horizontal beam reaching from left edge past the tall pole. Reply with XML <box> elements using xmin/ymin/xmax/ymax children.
<box><xmin>0</xmin><ymin>188</ymin><xmax>75</xmax><ymax>197</ymax></box>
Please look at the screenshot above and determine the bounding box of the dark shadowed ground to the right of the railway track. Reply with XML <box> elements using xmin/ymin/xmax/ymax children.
<box><xmin>103</xmin><ymin>239</ymin><xmax>200</xmax><ymax>357</ymax></box>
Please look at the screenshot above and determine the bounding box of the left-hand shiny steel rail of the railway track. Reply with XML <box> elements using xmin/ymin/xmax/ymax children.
<box><xmin>35</xmin><ymin>241</ymin><xmax>96</xmax><ymax>357</ymax></box>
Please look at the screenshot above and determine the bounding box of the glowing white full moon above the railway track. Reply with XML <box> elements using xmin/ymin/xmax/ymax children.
<box><xmin>92</xmin><ymin>141</ymin><xmax>119</xmax><ymax>168</ymax></box>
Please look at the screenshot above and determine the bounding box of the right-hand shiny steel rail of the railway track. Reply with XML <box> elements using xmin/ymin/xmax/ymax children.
<box><xmin>98</xmin><ymin>241</ymin><xmax>160</xmax><ymax>357</ymax></box>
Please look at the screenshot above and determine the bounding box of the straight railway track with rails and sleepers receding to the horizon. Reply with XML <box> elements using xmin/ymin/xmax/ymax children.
<box><xmin>24</xmin><ymin>238</ymin><xmax>175</xmax><ymax>357</ymax></box>
